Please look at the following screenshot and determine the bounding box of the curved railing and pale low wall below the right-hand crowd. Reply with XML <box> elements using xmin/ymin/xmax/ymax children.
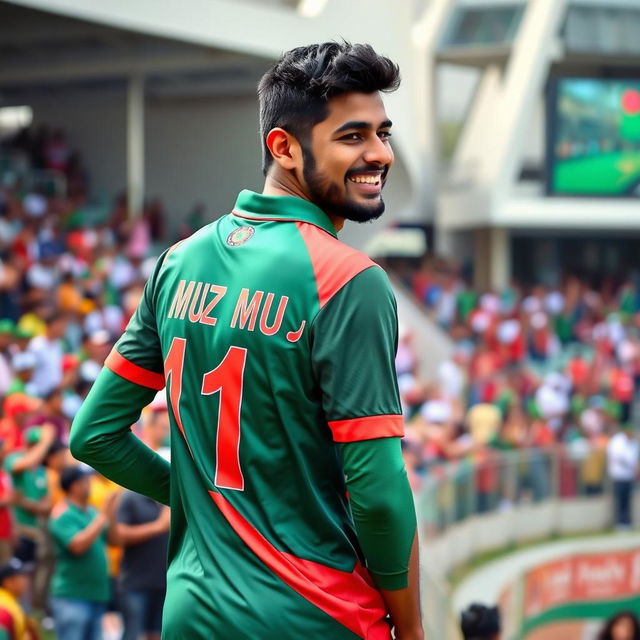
<box><xmin>415</xmin><ymin>440</ymin><xmax>610</xmax><ymax>640</ymax></box>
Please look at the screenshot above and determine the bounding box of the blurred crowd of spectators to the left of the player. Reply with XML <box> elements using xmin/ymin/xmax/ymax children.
<box><xmin>0</xmin><ymin>127</ymin><xmax>175</xmax><ymax>640</ymax></box>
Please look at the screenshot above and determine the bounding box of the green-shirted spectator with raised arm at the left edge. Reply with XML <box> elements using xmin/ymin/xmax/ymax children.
<box><xmin>5</xmin><ymin>425</ymin><xmax>55</xmax><ymax>563</ymax></box>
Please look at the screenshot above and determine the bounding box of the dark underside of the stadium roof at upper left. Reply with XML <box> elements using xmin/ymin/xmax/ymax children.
<box><xmin>0</xmin><ymin>2</ymin><xmax>268</xmax><ymax>105</ymax></box>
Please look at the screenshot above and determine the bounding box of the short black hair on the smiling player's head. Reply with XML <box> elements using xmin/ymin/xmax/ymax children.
<box><xmin>258</xmin><ymin>42</ymin><xmax>400</xmax><ymax>175</ymax></box>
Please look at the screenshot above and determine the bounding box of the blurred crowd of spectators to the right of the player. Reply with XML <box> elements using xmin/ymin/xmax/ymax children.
<box><xmin>392</xmin><ymin>260</ymin><xmax>640</xmax><ymax>528</ymax></box>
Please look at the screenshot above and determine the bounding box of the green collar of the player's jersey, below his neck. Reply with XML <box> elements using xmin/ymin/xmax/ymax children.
<box><xmin>233</xmin><ymin>189</ymin><xmax>338</xmax><ymax>238</ymax></box>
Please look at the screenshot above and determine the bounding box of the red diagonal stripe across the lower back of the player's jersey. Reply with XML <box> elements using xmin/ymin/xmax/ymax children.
<box><xmin>209</xmin><ymin>491</ymin><xmax>391</xmax><ymax>640</ymax></box>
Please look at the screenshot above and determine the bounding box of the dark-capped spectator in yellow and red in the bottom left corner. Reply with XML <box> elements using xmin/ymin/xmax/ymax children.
<box><xmin>0</xmin><ymin>558</ymin><xmax>39</xmax><ymax>640</ymax></box>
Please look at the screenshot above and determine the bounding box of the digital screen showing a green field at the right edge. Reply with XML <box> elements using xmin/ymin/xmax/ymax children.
<box><xmin>547</xmin><ymin>78</ymin><xmax>640</xmax><ymax>197</ymax></box>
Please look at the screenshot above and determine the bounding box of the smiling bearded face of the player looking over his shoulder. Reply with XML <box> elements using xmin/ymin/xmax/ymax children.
<box><xmin>301</xmin><ymin>93</ymin><xmax>393</xmax><ymax>222</ymax></box>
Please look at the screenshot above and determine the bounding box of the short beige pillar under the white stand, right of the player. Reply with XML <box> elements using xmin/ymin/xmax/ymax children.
<box><xmin>473</xmin><ymin>227</ymin><xmax>511</xmax><ymax>290</ymax></box>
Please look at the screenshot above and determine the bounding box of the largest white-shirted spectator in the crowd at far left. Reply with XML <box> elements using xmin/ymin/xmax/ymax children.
<box><xmin>29</xmin><ymin>311</ymin><xmax>67</xmax><ymax>397</ymax></box>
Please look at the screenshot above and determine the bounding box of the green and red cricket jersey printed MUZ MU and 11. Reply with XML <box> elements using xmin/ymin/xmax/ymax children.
<box><xmin>72</xmin><ymin>191</ymin><xmax>415</xmax><ymax>640</ymax></box>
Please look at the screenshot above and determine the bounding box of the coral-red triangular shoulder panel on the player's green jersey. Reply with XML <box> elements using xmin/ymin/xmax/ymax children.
<box><xmin>296</xmin><ymin>222</ymin><xmax>377</xmax><ymax>308</ymax></box>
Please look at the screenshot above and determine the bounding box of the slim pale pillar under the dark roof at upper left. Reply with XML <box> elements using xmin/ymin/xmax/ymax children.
<box><xmin>127</xmin><ymin>76</ymin><xmax>145</xmax><ymax>218</ymax></box>
